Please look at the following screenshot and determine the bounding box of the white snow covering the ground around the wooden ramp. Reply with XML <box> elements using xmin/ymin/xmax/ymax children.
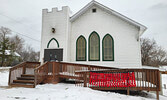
<box><xmin>0</xmin><ymin>70</ymin><xmax>167</xmax><ymax>100</ymax></box>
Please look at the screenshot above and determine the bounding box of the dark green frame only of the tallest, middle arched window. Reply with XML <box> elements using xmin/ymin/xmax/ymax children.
<box><xmin>88</xmin><ymin>31</ymin><xmax>100</xmax><ymax>61</ymax></box>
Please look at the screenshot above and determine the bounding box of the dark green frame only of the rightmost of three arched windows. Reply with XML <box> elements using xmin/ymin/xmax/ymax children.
<box><xmin>102</xmin><ymin>34</ymin><xmax>114</xmax><ymax>61</ymax></box>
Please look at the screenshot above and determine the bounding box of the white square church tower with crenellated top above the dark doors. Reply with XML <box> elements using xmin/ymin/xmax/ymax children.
<box><xmin>40</xmin><ymin>6</ymin><xmax>71</xmax><ymax>62</ymax></box>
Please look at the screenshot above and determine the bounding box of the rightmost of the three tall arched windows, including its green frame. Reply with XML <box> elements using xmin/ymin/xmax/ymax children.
<box><xmin>102</xmin><ymin>34</ymin><xmax>114</xmax><ymax>61</ymax></box>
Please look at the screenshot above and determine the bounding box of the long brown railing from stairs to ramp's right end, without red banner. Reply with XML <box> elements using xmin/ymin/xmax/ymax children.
<box><xmin>35</xmin><ymin>62</ymin><xmax>160</xmax><ymax>91</ymax></box>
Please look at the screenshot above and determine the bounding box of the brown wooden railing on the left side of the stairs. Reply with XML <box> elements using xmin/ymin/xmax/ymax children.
<box><xmin>8</xmin><ymin>62</ymin><xmax>40</xmax><ymax>85</ymax></box>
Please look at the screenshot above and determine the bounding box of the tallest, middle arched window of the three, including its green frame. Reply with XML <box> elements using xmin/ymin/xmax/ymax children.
<box><xmin>89</xmin><ymin>31</ymin><xmax>100</xmax><ymax>61</ymax></box>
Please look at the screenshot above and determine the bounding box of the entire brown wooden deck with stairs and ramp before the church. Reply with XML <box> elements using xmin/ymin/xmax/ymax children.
<box><xmin>9</xmin><ymin>62</ymin><xmax>160</xmax><ymax>99</ymax></box>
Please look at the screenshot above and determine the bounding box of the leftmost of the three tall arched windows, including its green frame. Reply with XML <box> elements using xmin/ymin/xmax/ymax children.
<box><xmin>76</xmin><ymin>36</ymin><xmax>86</xmax><ymax>61</ymax></box>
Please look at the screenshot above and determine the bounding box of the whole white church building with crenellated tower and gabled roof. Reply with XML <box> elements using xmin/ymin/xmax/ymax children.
<box><xmin>40</xmin><ymin>0</ymin><xmax>147</xmax><ymax>67</ymax></box>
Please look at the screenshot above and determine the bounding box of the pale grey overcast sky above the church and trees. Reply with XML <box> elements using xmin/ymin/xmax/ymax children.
<box><xmin>0</xmin><ymin>0</ymin><xmax>167</xmax><ymax>51</ymax></box>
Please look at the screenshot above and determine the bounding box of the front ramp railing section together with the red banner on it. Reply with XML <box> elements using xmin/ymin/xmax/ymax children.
<box><xmin>76</xmin><ymin>69</ymin><xmax>160</xmax><ymax>91</ymax></box>
